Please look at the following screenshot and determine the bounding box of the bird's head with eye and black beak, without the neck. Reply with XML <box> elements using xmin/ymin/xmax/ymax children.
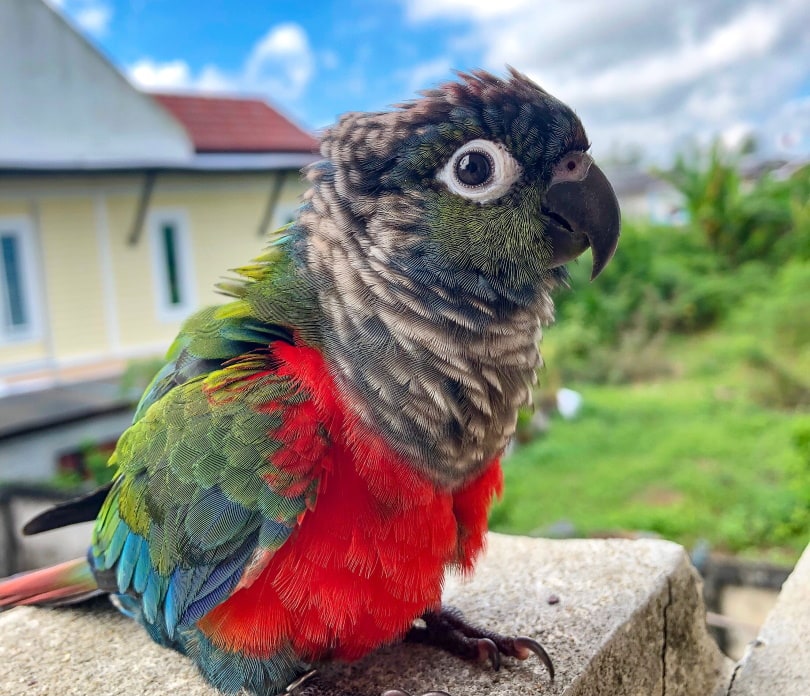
<box><xmin>316</xmin><ymin>70</ymin><xmax>620</xmax><ymax>302</ymax></box>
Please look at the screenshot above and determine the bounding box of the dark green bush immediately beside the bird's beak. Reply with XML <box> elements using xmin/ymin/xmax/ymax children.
<box><xmin>548</xmin><ymin>224</ymin><xmax>724</xmax><ymax>383</ymax></box>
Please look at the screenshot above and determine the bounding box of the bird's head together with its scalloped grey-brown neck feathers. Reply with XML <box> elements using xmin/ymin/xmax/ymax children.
<box><xmin>292</xmin><ymin>71</ymin><xmax>620</xmax><ymax>487</ymax></box>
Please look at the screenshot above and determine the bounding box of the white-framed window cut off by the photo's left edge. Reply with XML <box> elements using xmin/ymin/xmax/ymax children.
<box><xmin>0</xmin><ymin>218</ymin><xmax>37</xmax><ymax>343</ymax></box>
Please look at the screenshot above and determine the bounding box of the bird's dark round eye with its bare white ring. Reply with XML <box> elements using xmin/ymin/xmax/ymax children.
<box><xmin>436</xmin><ymin>138</ymin><xmax>521</xmax><ymax>203</ymax></box>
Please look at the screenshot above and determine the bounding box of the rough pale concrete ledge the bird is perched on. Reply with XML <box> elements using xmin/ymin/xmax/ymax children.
<box><xmin>0</xmin><ymin>534</ymin><xmax>728</xmax><ymax>696</ymax></box>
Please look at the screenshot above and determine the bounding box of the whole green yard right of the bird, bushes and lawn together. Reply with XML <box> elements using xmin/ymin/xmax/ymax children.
<box><xmin>516</xmin><ymin>152</ymin><xmax>810</xmax><ymax>558</ymax></box>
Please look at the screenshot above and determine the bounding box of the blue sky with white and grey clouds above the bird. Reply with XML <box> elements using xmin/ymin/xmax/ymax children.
<box><xmin>48</xmin><ymin>0</ymin><xmax>810</xmax><ymax>164</ymax></box>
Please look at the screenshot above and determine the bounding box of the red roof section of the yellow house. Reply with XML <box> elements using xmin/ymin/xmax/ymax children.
<box><xmin>152</xmin><ymin>94</ymin><xmax>318</xmax><ymax>152</ymax></box>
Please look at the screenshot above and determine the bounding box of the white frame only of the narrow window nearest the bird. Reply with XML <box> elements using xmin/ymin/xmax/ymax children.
<box><xmin>148</xmin><ymin>208</ymin><xmax>197</xmax><ymax>323</ymax></box>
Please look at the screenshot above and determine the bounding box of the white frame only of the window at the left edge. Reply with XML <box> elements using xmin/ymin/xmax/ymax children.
<box><xmin>0</xmin><ymin>217</ymin><xmax>42</xmax><ymax>345</ymax></box>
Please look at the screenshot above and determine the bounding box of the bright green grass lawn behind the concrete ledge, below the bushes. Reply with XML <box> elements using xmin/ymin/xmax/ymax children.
<box><xmin>491</xmin><ymin>337</ymin><xmax>810</xmax><ymax>561</ymax></box>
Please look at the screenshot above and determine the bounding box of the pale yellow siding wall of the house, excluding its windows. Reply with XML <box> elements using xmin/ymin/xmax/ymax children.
<box><xmin>0</xmin><ymin>173</ymin><xmax>304</xmax><ymax>384</ymax></box>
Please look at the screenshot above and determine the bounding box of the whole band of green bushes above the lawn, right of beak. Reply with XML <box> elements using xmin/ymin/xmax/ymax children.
<box><xmin>548</xmin><ymin>154</ymin><xmax>810</xmax><ymax>386</ymax></box>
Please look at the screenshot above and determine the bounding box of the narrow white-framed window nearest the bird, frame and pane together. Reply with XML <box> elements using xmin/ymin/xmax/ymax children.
<box><xmin>150</xmin><ymin>211</ymin><xmax>196</xmax><ymax>322</ymax></box>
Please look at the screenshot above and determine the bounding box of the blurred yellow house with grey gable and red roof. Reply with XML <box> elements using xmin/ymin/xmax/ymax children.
<box><xmin>0</xmin><ymin>0</ymin><xmax>317</xmax><ymax>394</ymax></box>
